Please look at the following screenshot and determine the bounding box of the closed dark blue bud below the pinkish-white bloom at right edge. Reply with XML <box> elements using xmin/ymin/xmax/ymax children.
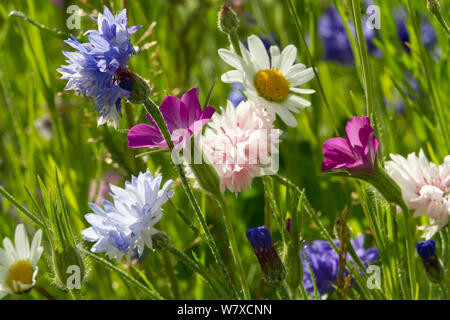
<box><xmin>416</xmin><ymin>240</ymin><xmax>445</xmax><ymax>283</ymax></box>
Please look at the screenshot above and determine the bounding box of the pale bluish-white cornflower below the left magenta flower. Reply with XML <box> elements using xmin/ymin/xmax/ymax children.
<box><xmin>81</xmin><ymin>169</ymin><xmax>174</xmax><ymax>261</ymax></box>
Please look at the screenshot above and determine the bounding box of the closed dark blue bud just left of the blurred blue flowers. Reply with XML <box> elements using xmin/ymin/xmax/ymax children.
<box><xmin>245</xmin><ymin>226</ymin><xmax>286</xmax><ymax>285</ymax></box>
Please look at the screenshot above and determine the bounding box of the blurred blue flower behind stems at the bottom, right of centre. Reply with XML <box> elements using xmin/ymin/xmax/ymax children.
<box><xmin>301</xmin><ymin>234</ymin><xmax>379</xmax><ymax>296</ymax></box>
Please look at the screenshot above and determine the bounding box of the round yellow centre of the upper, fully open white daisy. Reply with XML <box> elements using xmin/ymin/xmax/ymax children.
<box><xmin>253</xmin><ymin>68</ymin><xmax>290</xmax><ymax>102</ymax></box>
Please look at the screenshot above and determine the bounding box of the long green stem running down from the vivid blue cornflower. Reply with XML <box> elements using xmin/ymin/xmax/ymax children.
<box><xmin>144</xmin><ymin>98</ymin><xmax>239</xmax><ymax>298</ymax></box>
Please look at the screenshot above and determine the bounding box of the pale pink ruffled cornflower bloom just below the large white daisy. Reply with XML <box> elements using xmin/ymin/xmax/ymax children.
<box><xmin>201</xmin><ymin>101</ymin><xmax>281</xmax><ymax>194</ymax></box>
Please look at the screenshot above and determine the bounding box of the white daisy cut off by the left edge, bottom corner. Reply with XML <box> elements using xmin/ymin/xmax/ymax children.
<box><xmin>0</xmin><ymin>224</ymin><xmax>43</xmax><ymax>299</ymax></box>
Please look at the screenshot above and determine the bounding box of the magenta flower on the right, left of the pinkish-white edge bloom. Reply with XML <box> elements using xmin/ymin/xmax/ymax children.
<box><xmin>322</xmin><ymin>117</ymin><xmax>380</xmax><ymax>173</ymax></box>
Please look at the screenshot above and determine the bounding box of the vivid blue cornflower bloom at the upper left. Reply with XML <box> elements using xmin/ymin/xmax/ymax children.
<box><xmin>57</xmin><ymin>7</ymin><xmax>141</xmax><ymax>128</ymax></box>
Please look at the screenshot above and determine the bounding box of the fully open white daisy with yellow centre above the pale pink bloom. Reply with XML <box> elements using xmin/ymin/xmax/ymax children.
<box><xmin>219</xmin><ymin>35</ymin><xmax>315</xmax><ymax>127</ymax></box>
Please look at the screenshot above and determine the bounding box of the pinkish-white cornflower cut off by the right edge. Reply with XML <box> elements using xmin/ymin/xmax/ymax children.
<box><xmin>386</xmin><ymin>150</ymin><xmax>450</xmax><ymax>239</ymax></box>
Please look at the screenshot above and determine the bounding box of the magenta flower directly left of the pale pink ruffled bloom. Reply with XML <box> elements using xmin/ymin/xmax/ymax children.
<box><xmin>127</xmin><ymin>88</ymin><xmax>216</xmax><ymax>148</ymax></box>
